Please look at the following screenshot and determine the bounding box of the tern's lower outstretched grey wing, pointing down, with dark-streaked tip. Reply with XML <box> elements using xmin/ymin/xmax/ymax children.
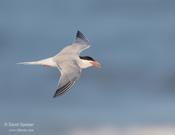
<box><xmin>54</xmin><ymin>61</ymin><xmax>81</xmax><ymax>97</ymax></box>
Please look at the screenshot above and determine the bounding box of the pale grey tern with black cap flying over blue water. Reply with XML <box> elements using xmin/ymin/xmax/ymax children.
<box><xmin>17</xmin><ymin>30</ymin><xmax>101</xmax><ymax>97</ymax></box>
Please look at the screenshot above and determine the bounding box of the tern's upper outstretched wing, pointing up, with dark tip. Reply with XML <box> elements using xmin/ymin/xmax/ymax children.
<box><xmin>59</xmin><ymin>31</ymin><xmax>90</xmax><ymax>55</ymax></box>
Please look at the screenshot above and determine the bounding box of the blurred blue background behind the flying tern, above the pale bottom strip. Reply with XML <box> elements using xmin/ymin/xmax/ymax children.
<box><xmin>0</xmin><ymin>0</ymin><xmax>175</xmax><ymax>135</ymax></box>
